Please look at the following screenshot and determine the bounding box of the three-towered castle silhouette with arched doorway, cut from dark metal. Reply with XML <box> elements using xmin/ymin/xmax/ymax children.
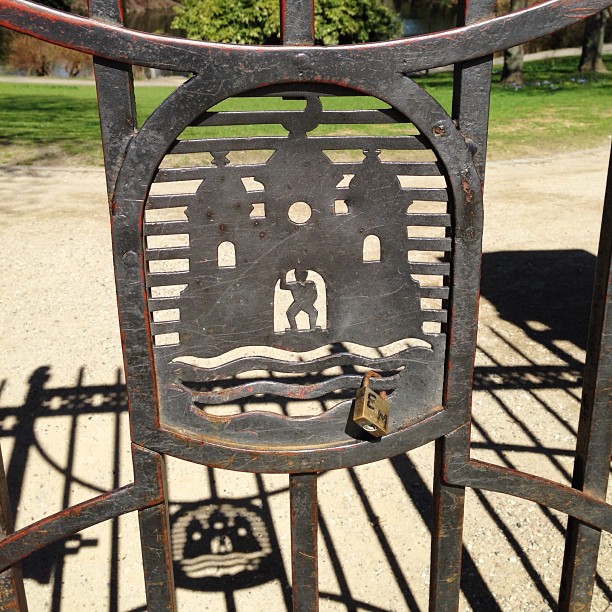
<box><xmin>145</xmin><ymin>98</ymin><xmax>450</xmax><ymax>357</ymax></box>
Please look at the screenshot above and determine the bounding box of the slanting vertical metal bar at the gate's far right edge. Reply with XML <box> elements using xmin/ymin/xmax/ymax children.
<box><xmin>559</xmin><ymin>152</ymin><xmax>612</xmax><ymax>611</ymax></box>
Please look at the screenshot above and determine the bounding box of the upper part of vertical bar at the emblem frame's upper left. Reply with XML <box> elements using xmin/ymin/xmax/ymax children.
<box><xmin>89</xmin><ymin>0</ymin><xmax>136</xmax><ymax>201</ymax></box>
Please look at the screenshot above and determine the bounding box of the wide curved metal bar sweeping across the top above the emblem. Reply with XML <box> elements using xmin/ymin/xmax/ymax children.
<box><xmin>0</xmin><ymin>0</ymin><xmax>610</xmax><ymax>73</ymax></box>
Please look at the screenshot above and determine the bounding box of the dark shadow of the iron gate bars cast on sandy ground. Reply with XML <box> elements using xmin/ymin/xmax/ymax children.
<box><xmin>0</xmin><ymin>251</ymin><xmax>612</xmax><ymax>612</ymax></box>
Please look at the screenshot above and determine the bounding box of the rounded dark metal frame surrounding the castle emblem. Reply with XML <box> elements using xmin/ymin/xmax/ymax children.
<box><xmin>107</xmin><ymin>66</ymin><xmax>482</xmax><ymax>472</ymax></box>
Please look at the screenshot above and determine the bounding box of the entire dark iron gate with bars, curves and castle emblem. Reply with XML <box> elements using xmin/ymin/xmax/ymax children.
<box><xmin>0</xmin><ymin>0</ymin><xmax>612</xmax><ymax>610</ymax></box>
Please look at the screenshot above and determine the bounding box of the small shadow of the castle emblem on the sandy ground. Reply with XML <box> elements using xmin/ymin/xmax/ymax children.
<box><xmin>171</xmin><ymin>500</ymin><xmax>274</xmax><ymax>591</ymax></box>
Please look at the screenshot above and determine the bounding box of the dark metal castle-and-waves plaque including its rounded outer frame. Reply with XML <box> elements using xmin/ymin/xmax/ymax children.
<box><xmin>112</xmin><ymin>71</ymin><xmax>481</xmax><ymax>471</ymax></box>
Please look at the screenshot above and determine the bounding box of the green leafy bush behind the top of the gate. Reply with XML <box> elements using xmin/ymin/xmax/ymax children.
<box><xmin>172</xmin><ymin>0</ymin><xmax>400</xmax><ymax>45</ymax></box>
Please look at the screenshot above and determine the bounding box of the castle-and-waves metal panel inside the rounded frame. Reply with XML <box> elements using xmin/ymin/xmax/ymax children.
<box><xmin>145</xmin><ymin>92</ymin><xmax>451</xmax><ymax>442</ymax></box>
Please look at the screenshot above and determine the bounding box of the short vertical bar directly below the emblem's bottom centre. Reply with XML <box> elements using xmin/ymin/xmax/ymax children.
<box><xmin>289</xmin><ymin>474</ymin><xmax>319</xmax><ymax>612</ymax></box>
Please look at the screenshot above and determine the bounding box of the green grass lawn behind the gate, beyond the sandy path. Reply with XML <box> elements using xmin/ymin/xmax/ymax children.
<box><xmin>0</xmin><ymin>56</ymin><xmax>612</xmax><ymax>164</ymax></box>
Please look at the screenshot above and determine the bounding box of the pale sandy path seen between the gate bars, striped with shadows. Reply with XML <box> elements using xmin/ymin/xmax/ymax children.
<box><xmin>0</xmin><ymin>149</ymin><xmax>612</xmax><ymax>612</ymax></box>
